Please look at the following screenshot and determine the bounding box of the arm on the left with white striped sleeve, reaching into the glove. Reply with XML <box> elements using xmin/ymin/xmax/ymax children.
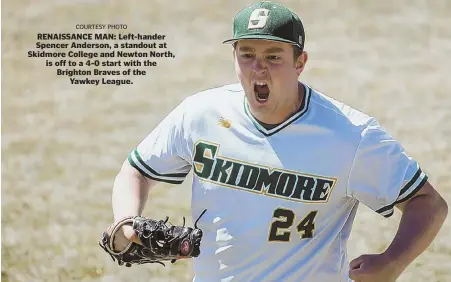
<box><xmin>112</xmin><ymin>100</ymin><xmax>195</xmax><ymax>247</ymax></box>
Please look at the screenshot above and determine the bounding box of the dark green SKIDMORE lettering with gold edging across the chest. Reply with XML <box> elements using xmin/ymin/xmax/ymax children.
<box><xmin>194</xmin><ymin>141</ymin><xmax>337</xmax><ymax>203</ymax></box>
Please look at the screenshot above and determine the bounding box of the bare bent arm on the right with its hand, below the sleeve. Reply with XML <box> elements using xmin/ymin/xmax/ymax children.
<box><xmin>349</xmin><ymin>181</ymin><xmax>448</xmax><ymax>282</ymax></box>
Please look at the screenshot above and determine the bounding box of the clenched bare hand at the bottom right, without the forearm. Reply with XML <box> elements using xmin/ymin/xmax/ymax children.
<box><xmin>349</xmin><ymin>254</ymin><xmax>401</xmax><ymax>282</ymax></box>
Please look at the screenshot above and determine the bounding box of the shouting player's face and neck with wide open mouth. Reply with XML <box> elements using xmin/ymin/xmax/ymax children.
<box><xmin>234</xmin><ymin>40</ymin><xmax>307</xmax><ymax>124</ymax></box>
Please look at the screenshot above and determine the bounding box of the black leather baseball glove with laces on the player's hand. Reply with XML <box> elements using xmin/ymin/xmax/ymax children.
<box><xmin>99</xmin><ymin>210</ymin><xmax>206</xmax><ymax>267</ymax></box>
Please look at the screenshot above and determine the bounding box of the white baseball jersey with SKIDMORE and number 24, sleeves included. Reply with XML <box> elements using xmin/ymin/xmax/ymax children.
<box><xmin>129</xmin><ymin>84</ymin><xmax>427</xmax><ymax>282</ymax></box>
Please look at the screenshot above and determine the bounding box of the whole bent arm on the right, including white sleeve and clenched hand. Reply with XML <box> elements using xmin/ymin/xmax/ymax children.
<box><xmin>347</xmin><ymin>119</ymin><xmax>448</xmax><ymax>282</ymax></box>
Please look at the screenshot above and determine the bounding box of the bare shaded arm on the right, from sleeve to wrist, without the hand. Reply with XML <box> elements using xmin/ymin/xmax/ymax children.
<box><xmin>385</xmin><ymin>181</ymin><xmax>448</xmax><ymax>274</ymax></box>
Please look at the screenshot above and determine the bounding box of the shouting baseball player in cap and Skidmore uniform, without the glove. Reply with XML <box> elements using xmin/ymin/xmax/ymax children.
<box><xmin>113</xmin><ymin>1</ymin><xmax>448</xmax><ymax>282</ymax></box>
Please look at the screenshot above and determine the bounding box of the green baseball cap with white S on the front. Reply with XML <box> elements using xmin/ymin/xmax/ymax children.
<box><xmin>223</xmin><ymin>1</ymin><xmax>305</xmax><ymax>50</ymax></box>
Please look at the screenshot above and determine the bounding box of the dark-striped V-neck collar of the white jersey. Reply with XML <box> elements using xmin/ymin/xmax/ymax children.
<box><xmin>243</xmin><ymin>83</ymin><xmax>312</xmax><ymax>136</ymax></box>
